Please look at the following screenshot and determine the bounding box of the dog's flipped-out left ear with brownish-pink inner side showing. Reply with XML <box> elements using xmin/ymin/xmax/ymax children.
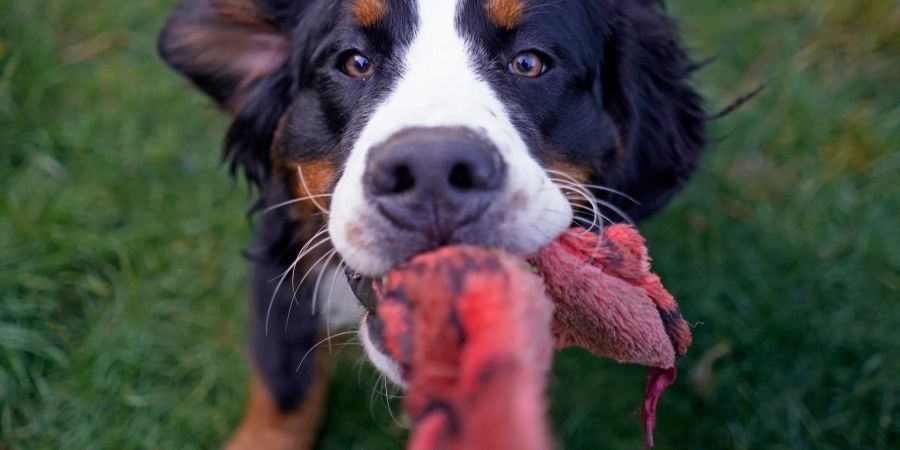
<box><xmin>158</xmin><ymin>0</ymin><xmax>289</xmax><ymax>113</ymax></box>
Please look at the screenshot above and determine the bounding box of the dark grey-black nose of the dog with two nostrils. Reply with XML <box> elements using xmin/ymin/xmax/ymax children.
<box><xmin>363</xmin><ymin>128</ymin><xmax>506</xmax><ymax>244</ymax></box>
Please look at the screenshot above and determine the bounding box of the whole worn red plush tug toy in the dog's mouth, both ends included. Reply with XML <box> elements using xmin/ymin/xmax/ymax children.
<box><xmin>377</xmin><ymin>225</ymin><xmax>691</xmax><ymax>450</ymax></box>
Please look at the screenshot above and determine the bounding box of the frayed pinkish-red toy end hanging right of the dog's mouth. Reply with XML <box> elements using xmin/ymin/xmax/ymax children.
<box><xmin>530</xmin><ymin>225</ymin><xmax>691</xmax><ymax>447</ymax></box>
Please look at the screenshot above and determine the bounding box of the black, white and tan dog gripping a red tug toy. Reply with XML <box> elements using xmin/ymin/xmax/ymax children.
<box><xmin>158</xmin><ymin>0</ymin><xmax>707</xmax><ymax>449</ymax></box>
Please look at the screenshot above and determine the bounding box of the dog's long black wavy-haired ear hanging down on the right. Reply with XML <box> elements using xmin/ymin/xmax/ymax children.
<box><xmin>602</xmin><ymin>0</ymin><xmax>706</xmax><ymax>220</ymax></box>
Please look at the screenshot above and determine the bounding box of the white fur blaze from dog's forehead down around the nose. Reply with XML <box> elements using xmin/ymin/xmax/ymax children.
<box><xmin>329</xmin><ymin>0</ymin><xmax>572</xmax><ymax>275</ymax></box>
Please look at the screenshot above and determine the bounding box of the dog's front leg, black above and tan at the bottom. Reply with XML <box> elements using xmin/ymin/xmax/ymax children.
<box><xmin>226</xmin><ymin>243</ymin><xmax>330</xmax><ymax>450</ymax></box>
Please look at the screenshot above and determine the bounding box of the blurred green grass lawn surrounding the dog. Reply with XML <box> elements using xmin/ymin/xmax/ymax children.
<box><xmin>0</xmin><ymin>0</ymin><xmax>900</xmax><ymax>449</ymax></box>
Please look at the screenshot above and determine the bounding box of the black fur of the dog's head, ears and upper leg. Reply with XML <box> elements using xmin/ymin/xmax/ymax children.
<box><xmin>159</xmin><ymin>0</ymin><xmax>706</xmax><ymax>411</ymax></box>
